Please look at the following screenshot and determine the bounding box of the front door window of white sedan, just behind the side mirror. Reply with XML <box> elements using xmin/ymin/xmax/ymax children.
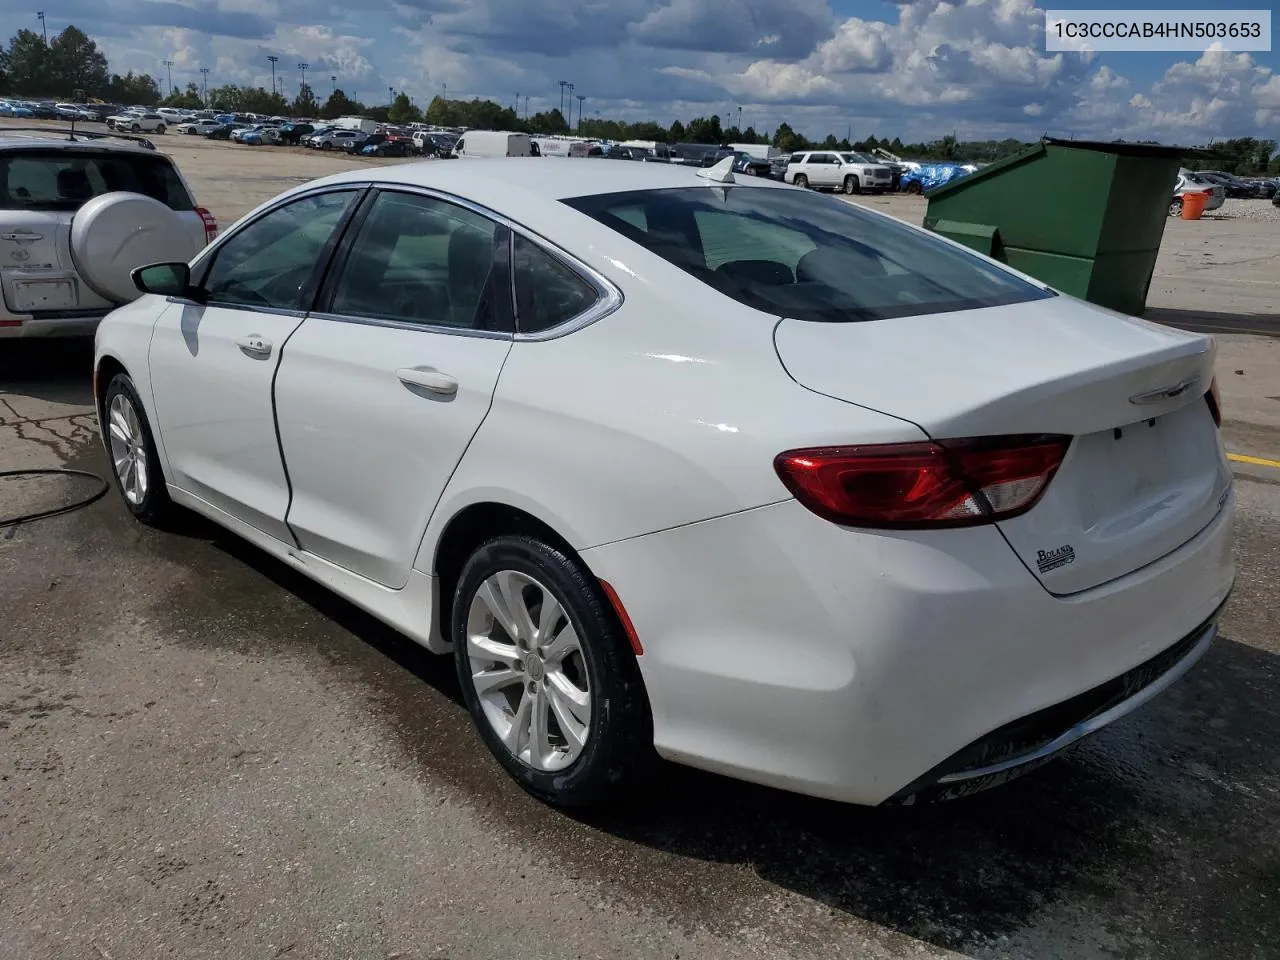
<box><xmin>202</xmin><ymin>189</ymin><xmax>360</xmax><ymax>316</ymax></box>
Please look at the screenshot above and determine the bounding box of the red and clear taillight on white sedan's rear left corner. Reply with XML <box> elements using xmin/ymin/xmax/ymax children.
<box><xmin>773</xmin><ymin>435</ymin><xmax>1071</xmax><ymax>530</ymax></box>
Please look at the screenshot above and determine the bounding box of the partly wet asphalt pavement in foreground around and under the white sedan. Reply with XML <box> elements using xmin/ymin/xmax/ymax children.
<box><xmin>0</xmin><ymin>344</ymin><xmax>1280</xmax><ymax>960</ymax></box>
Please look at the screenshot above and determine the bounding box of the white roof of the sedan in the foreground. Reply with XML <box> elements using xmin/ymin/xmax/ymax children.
<box><xmin>311</xmin><ymin>156</ymin><xmax>791</xmax><ymax>202</ymax></box>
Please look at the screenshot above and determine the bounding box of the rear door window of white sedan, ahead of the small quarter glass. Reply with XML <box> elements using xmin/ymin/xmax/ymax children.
<box><xmin>325</xmin><ymin>191</ymin><xmax>511</xmax><ymax>332</ymax></box>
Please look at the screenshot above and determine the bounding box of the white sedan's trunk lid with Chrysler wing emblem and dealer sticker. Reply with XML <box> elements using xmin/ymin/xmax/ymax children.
<box><xmin>774</xmin><ymin>296</ymin><xmax>1231</xmax><ymax>595</ymax></box>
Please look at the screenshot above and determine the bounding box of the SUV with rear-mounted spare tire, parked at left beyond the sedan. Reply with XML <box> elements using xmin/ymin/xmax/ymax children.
<box><xmin>0</xmin><ymin>134</ymin><xmax>218</xmax><ymax>339</ymax></box>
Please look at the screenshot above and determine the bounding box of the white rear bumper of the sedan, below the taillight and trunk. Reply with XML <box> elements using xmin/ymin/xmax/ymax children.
<box><xmin>582</xmin><ymin>499</ymin><xmax>1235</xmax><ymax>805</ymax></box>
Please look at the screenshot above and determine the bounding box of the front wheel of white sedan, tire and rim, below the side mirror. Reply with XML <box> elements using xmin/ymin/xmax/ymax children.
<box><xmin>102</xmin><ymin>374</ymin><xmax>177</xmax><ymax>526</ymax></box>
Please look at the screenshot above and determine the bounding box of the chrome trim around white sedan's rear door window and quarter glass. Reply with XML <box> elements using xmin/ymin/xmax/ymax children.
<box><xmin>325</xmin><ymin>180</ymin><xmax>623</xmax><ymax>343</ymax></box>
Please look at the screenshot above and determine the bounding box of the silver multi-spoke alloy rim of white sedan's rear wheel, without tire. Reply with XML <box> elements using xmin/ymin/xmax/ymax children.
<box><xmin>466</xmin><ymin>570</ymin><xmax>591</xmax><ymax>772</ymax></box>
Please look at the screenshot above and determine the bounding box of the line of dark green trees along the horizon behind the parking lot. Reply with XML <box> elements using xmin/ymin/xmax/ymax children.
<box><xmin>0</xmin><ymin>27</ymin><xmax>1280</xmax><ymax>175</ymax></box>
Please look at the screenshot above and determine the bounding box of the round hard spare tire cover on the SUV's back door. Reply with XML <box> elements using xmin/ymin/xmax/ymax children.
<box><xmin>70</xmin><ymin>191</ymin><xmax>198</xmax><ymax>303</ymax></box>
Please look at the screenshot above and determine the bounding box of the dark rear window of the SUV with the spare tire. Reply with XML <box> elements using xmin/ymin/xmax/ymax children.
<box><xmin>0</xmin><ymin>150</ymin><xmax>196</xmax><ymax>211</ymax></box>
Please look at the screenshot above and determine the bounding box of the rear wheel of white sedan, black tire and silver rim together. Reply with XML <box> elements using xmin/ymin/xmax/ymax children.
<box><xmin>452</xmin><ymin>536</ymin><xmax>654</xmax><ymax>806</ymax></box>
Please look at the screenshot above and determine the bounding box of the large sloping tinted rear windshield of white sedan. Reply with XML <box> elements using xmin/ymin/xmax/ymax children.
<box><xmin>564</xmin><ymin>184</ymin><xmax>1056</xmax><ymax>323</ymax></box>
